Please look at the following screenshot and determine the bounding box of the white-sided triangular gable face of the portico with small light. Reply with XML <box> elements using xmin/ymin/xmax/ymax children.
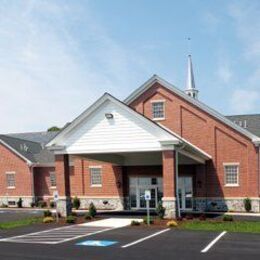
<box><xmin>55</xmin><ymin>99</ymin><xmax>179</xmax><ymax>154</ymax></box>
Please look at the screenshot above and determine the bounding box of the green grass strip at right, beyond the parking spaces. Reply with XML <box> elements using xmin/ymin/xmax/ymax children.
<box><xmin>179</xmin><ymin>220</ymin><xmax>260</xmax><ymax>233</ymax></box>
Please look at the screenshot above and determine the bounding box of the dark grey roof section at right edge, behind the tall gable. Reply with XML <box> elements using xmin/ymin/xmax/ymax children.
<box><xmin>226</xmin><ymin>114</ymin><xmax>260</xmax><ymax>137</ymax></box>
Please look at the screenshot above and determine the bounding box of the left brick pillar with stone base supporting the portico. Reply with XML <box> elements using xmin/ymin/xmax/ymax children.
<box><xmin>55</xmin><ymin>154</ymin><xmax>71</xmax><ymax>217</ymax></box>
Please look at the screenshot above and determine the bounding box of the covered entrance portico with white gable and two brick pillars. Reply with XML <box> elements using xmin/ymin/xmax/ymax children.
<box><xmin>48</xmin><ymin>94</ymin><xmax>210</xmax><ymax>218</ymax></box>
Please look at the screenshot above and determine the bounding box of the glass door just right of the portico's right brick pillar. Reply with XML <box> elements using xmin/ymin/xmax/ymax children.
<box><xmin>178</xmin><ymin>176</ymin><xmax>193</xmax><ymax>210</ymax></box>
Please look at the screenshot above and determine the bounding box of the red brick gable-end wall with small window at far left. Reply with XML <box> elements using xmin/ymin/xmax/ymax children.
<box><xmin>0</xmin><ymin>144</ymin><xmax>32</xmax><ymax>196</ymax></box>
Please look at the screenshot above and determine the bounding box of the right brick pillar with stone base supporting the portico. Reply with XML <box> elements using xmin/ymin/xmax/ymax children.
<box><xmin>162</xmin><ymin>150</ymin><xmax>176</xmax><ymax>219</ymax></box>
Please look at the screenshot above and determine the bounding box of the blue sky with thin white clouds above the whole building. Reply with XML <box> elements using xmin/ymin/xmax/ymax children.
<box><xmin>0</xmin><ymin>0</ymin><xmax>260</xmax><ymax>133</ymax></box>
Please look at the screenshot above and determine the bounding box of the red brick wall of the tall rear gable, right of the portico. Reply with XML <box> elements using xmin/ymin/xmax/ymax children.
<box><xmin>131</xmin><ymin>83</ymin><xmax>258</xmax><ymax>197</ymax></box>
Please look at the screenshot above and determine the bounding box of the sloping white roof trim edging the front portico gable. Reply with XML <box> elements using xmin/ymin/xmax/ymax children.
<box><xmin>46</xmin><ymin>93</ymin><xmax>211</xmax><ymax>160</ymax></box>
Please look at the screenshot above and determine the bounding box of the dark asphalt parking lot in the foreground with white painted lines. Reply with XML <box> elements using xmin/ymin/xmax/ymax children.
<box><xmin>0</xmin><ymin>223</ymin><xmax>260</xmax><ymax>260</ymax></box>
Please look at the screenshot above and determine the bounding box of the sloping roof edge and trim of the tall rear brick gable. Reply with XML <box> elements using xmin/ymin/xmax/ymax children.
<box><xmin>124</xmin><ymin>75</ymin><xmax>260</xmax><ymax>145</ymax></box>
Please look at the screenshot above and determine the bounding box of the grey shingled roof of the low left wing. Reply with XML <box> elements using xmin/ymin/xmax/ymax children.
<box><xmin>0</xmin><ymin>132</ymin><xmax>57</xmax><ymax>164</ymax></box>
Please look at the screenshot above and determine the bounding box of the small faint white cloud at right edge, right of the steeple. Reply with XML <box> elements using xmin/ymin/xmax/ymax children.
<box><xmin>230</xmin><ymin>89</ymin><xmax>260</xmax><ymax>114</ymax></box>
